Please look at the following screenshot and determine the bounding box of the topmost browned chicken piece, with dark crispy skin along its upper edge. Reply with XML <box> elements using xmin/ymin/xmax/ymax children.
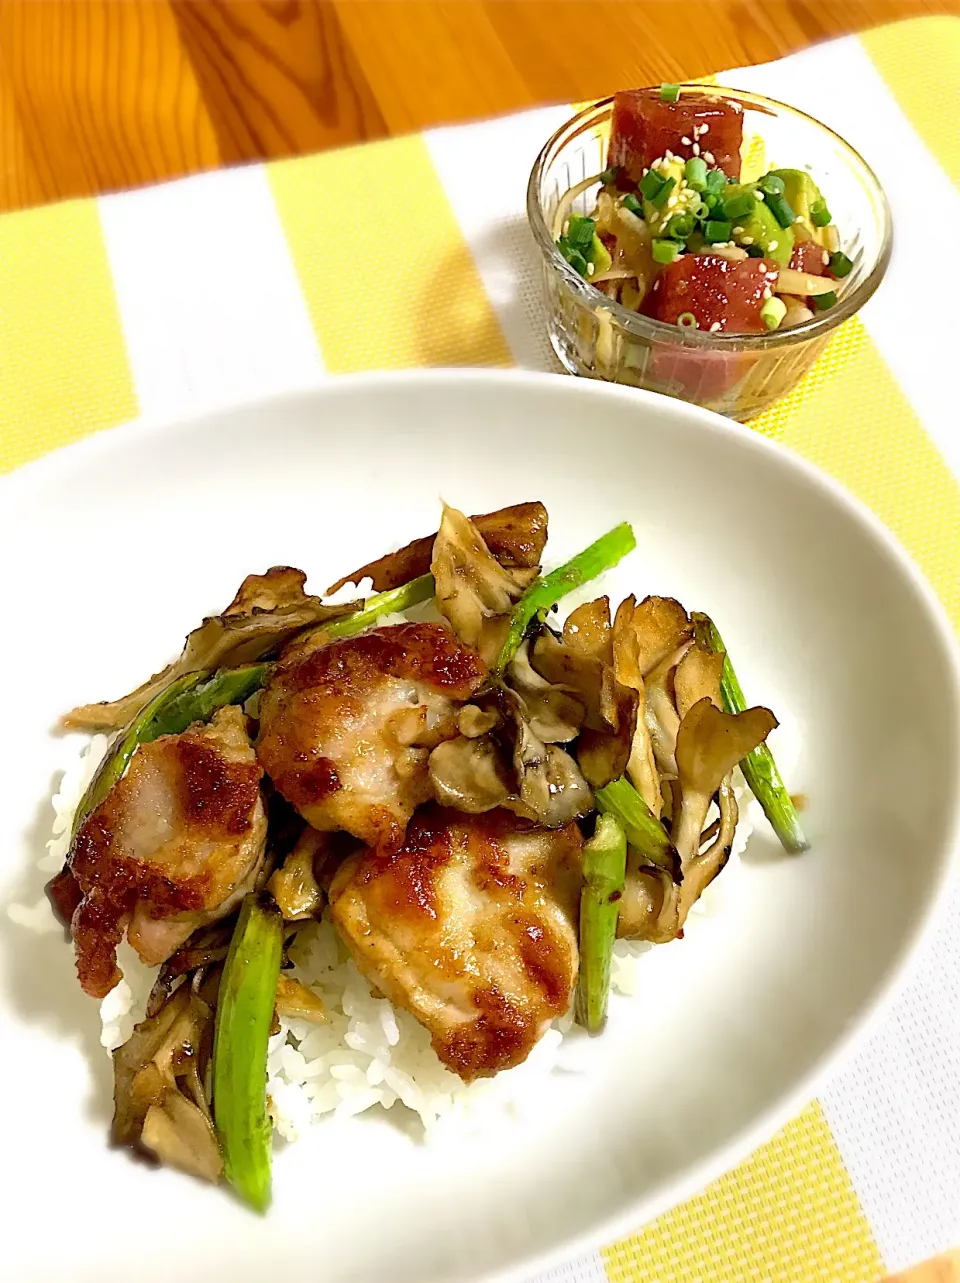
<box><xmin>257</xmin><ymin>624</ymin><xmax>486</xmax><ymax>851</ymax></box>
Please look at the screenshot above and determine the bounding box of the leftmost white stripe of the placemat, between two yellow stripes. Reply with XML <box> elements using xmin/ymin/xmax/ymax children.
<box><xmin>100</xmin><ymin>166</ymin><xmax>323</xmax><ymax>417</ymax></box>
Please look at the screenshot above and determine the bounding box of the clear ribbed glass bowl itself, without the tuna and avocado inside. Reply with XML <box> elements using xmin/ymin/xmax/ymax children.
<box><xmin>526</xmin><ymin>85</ymin><xmax>892</xmax><ymax>422</ymax></box>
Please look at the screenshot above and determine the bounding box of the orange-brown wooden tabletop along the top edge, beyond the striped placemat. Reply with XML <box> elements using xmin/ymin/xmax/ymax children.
<box><xmin>0</xmin><ymin>0</ymin><xmax>960</xmax><ymax>209</ymax></box>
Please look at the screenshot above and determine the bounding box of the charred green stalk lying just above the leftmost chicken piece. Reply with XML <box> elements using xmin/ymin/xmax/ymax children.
<box><xmin>73</xmin><ymin>663</ymin><xmax>267</xmax><ymax>835</ymax></box>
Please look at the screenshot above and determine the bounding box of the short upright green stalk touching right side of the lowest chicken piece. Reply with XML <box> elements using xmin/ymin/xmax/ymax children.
<box><xmin>576</xmin><ymin>815</ymin><xmax>626</xmax><ymax>1034</ymax></box>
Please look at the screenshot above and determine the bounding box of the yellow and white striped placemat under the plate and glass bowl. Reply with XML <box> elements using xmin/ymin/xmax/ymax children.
<box><xmin>0</xmin><ymin>12</ymin><xmax>960</xmax><ymax>1283</ymax></box>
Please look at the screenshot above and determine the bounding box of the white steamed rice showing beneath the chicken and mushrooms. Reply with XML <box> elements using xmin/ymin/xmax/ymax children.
<box><xmin>8</xmin><ymin>735</ymin><xmax>753</xmax><ymax>1141</ymax></box>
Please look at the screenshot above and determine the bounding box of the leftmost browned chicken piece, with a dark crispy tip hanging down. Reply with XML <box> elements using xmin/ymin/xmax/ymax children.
<box><xmin>68</xmin><ymin>706</ymin><xmax>267</xmax><ymax>998</ymax></box>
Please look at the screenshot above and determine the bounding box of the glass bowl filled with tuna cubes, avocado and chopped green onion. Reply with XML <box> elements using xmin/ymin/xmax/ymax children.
<box><xmin>527</xmin><ymin>85</ymin><xmax>891</xmax><ymax>420</ymax></box>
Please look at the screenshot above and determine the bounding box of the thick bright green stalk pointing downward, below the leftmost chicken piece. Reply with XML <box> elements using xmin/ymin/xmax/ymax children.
<box><xmin>213</xmin><ymin>894</ymin><xmax>284</xmax><ymax>1211</ymax></box>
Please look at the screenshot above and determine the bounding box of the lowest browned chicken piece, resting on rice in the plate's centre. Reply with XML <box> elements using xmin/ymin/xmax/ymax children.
<box><xmin>330</xmin><ymin>806</ymin><xmax>581</xmax><ymax>1082</ymax></box>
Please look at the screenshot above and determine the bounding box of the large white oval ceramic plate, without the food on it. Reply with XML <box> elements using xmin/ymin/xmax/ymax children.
<box><xmin>0</xmin><ymin>371</ymin><xmax>960</xmax><ymax>1283</ymax></box>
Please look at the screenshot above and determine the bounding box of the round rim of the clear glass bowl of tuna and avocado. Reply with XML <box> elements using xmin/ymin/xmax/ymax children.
<box><xmin>526</xmin><ymin>82</ymin><xmax>893</xmax><ymax>353</ymax></box>
